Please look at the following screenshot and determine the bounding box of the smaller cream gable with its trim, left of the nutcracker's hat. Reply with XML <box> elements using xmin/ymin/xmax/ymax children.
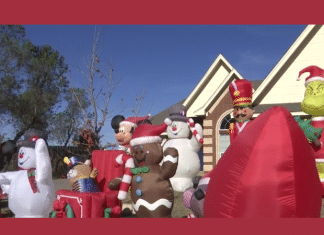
<box><xmin>183</xmin><ymin>54</ymin><xmax>243</xmax><ymax>117</ymax></box>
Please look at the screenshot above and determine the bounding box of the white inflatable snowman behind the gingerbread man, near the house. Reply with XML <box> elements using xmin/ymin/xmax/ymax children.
<box><xmin>162</xmin><ymin>104</ymin><xmax>202</xmax><ymax>192</ymax></box>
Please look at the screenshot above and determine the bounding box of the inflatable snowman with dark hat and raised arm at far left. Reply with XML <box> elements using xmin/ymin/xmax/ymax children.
<box><xmin>0</xmin><ymin>129</ymin><xmax>55</xmax><ymax>218</ymax></box>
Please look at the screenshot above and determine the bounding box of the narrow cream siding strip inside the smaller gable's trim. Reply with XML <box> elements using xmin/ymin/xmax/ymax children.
<box><xmin>187</xmin><ymin>66</ymin><xmax>230</xmax><ymax>117</ymax></box>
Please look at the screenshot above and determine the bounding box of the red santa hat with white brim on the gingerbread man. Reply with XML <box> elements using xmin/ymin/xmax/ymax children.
<box><xmin>130</xmin><ymin>123</ymin><xmax>168</xmax><ymax>146</ymax></box>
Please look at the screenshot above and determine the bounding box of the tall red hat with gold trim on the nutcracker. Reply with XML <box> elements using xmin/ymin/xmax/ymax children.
<box><xmin>229</xmin><ymin>79</ymin><xmax>253</xmax><ymax>106</ymax></box>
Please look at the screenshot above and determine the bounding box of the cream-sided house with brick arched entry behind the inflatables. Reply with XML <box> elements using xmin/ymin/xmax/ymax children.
<box><xmin>152</xmin><ymin>25</ymin><xmax>324</xmax><ymax>173</ymax></box>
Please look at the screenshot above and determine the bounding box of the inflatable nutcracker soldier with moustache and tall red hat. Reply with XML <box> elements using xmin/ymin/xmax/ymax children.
<box><xmin>229</xmin><ymin>79</ymin><xmax>254</xmax><ymax>143</ymax></box>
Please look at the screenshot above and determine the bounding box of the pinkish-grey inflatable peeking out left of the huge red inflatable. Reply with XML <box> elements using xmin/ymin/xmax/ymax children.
<box><xmin>183</xmin><ymin>172</ymin><xmax>210</xmax><ymax>218</ymax></box>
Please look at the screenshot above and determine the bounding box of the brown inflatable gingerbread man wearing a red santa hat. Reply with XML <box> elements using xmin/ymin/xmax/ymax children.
<box><xmin>130</xmin><ymin>123</ymin><xmax>178</xmax><ymax>218</ymax></box>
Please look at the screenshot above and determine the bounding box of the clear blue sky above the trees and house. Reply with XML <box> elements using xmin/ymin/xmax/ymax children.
<box><xmin>5</xmin><ymin>25</ymin><xmax>306</xmax><ymax>143</ymax></box>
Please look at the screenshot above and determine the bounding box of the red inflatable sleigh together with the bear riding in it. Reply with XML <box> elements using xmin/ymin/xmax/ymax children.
<box><xmin>52</xmin><ymin>150</ymin><xmax>125</xmax><ymax>218</ymax></box>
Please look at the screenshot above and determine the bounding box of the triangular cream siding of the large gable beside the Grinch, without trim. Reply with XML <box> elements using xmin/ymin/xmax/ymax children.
<box><xmin>260</xmin><ymin>27</ymin><xmax>324</xmax><ymax>104</ymax></box>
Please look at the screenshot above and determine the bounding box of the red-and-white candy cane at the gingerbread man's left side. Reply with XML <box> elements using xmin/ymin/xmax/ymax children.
<box><xmin>116</xmin><ymin>154</ymin><xmax>135</xmax><ymax>200</ymax></box>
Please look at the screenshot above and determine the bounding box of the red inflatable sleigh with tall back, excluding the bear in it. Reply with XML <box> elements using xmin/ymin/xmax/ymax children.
<box><xmin>51</xmin><ymin>150</ymin><xmax>127</xmax><ymax>218</ymax></box>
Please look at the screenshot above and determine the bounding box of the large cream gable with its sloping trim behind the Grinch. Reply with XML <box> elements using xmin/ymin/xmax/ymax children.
<box><xmin>253</xmin><ymin>25</ymin><xmax>324</xmax><ymax>105</ymax></box>
